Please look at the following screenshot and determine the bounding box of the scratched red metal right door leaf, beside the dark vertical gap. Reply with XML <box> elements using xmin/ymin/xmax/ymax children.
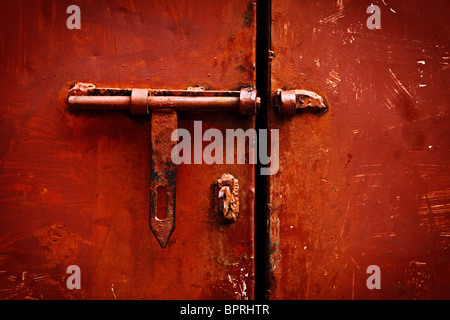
<box><xmin>269</xmin><ymin>0</ymin><xmax>450</xmax><ymax>299</ymax></box>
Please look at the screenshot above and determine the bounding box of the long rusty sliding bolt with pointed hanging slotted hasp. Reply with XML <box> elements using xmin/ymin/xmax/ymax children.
<box><xmin>67</xmin><ymin>82</ymin><xmax>260</xmax><ymax>248</ymax></box>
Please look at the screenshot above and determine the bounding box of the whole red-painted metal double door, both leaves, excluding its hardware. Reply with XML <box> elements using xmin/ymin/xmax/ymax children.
<box><xmin>0</xmin><ymin>0</ymin><xmax>450</xmax><ymax>300</ymax></box>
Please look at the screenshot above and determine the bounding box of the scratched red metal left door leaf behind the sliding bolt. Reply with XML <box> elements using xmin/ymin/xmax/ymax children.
<box><xmin>0</xmin><ymin>0</ymin><xmax>255</xmax><ymax>299</ymax></box>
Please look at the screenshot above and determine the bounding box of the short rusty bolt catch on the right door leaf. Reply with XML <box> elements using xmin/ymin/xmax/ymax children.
<box><xmin>274</xmin><ymin>89</ymin><xmax>328</xmax><ymax>116</ymax></box>
